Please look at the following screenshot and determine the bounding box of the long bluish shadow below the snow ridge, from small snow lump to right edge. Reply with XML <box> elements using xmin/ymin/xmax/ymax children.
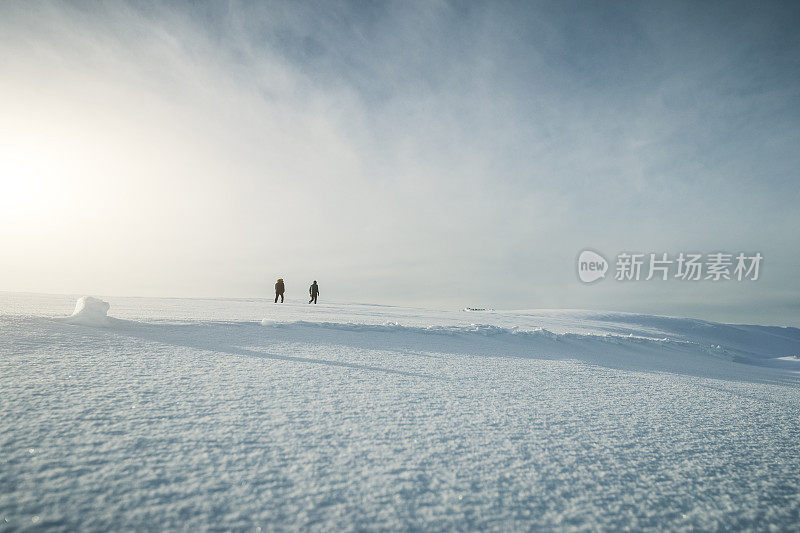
<box><xmin>70</xmin><ymin>321</ymin><xmax>800</xmax><ymax>386</ymax></box>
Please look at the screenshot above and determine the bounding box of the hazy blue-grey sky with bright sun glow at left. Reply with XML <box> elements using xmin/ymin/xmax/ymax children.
<box><xmin>0</xmin><ymin>1</ymin><xmax>800</xmax><ymax>326</ymax></box>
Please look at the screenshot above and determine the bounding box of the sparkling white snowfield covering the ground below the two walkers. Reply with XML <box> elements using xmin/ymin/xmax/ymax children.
<box><xmin>0</xmin><ymin>294</ymin><xmax>800</xmax><ymax>531</ymax></box>
